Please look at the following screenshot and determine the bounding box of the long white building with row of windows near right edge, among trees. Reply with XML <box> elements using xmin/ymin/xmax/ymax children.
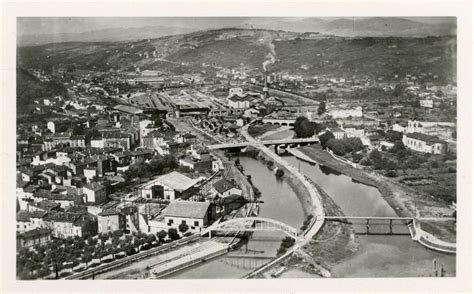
<box><xmin>402</xmin><ymin>133</ymin><xmax>448</xmax><ymax>154</ymax></box>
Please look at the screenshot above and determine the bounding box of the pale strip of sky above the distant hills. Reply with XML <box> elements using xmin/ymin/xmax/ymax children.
<box><xmin>17</xmin><ymin>17</ymin><xmax>455</xmax><ymax>35</ymax></box>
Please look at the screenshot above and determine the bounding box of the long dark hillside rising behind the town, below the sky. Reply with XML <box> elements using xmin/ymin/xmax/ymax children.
<box><xmin>18</xmin><ymin>29</ymin><xmax>456</xmax><ymax>80</ymax></box>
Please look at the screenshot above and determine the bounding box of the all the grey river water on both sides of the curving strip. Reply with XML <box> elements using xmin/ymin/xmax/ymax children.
<box><xmin>103</xmin><ymin>131</ymin><xmax>456</xmax><ymax>279</ymax></box>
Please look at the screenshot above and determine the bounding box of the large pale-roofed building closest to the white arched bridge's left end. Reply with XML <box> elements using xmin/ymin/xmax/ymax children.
<box><xmin>162</xmin><ymin>201</ymin><xmax>211</xmax><ymax>232</ymax></box>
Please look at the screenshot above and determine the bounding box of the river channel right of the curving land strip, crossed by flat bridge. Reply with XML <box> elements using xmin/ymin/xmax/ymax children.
<box><xmin>285</xmin><ymin>156</ymin><xmax>456</xmax><ymax>277</ymax></box>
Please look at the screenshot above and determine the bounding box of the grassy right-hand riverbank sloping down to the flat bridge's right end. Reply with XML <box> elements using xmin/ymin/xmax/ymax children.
<box><xmin>299</xmin><ymin>145</ymin><xmax>456</xmax><ymax>248</ymax></box>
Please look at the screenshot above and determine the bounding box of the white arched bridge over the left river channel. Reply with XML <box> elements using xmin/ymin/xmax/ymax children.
<box><xmin>201</xmin><ymin>217</ymin><xmax>299</xmax><ymax>241</ymax></box>
